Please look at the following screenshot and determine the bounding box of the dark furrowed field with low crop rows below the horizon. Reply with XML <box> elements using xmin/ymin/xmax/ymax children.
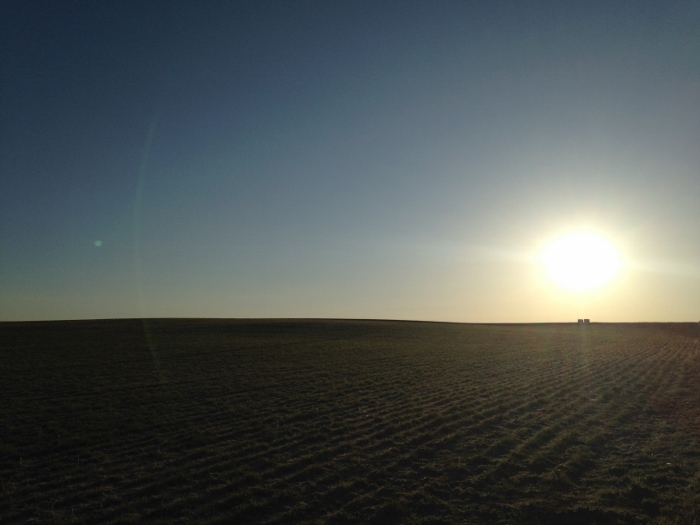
<box><xmin>0</xmin><ymin>320</ymin><xmax>700</xmax><ymax>525</ymax></box>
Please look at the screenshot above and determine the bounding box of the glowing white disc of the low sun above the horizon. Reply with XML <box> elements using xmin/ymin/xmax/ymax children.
<box><xmin>542</xmin><ymin>232</ymin><xmax>620</xmax><ymax>291</ymax></box>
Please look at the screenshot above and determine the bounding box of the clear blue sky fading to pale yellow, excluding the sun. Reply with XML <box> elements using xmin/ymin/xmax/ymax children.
<box><xmin>0</xmin><ymin>0</ymin><xmax>700</xmax><ymax>323</ymax></box>
